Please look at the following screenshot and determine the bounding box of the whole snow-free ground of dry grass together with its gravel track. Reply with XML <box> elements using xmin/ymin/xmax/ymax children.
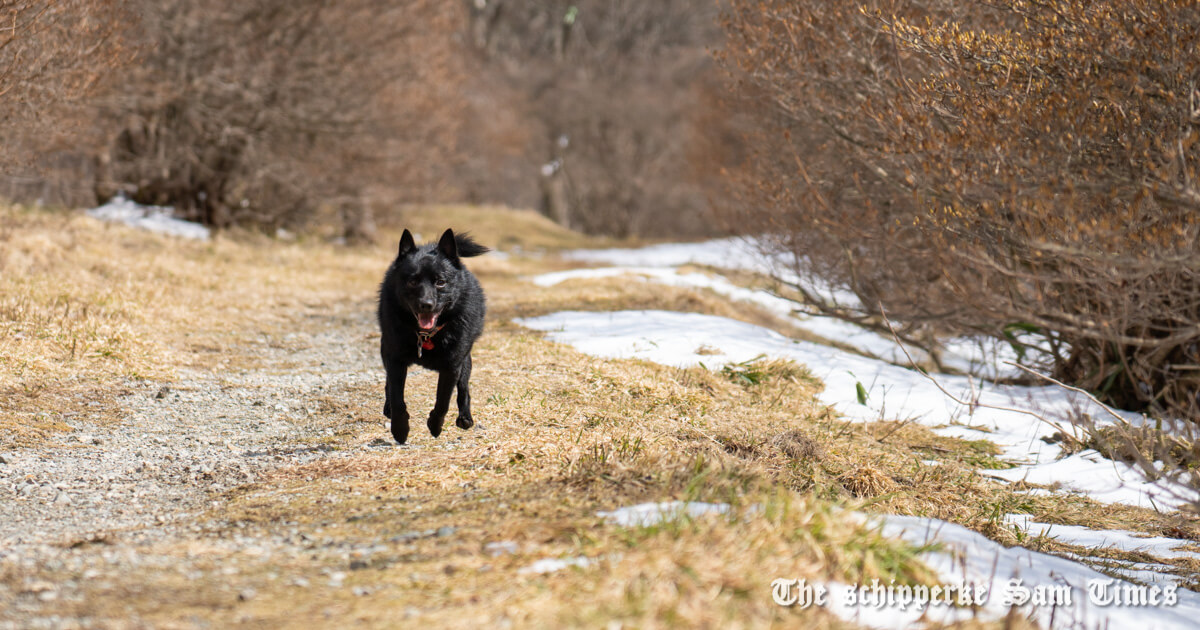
<box><xmin>0</xmin><ymin>208</ymin><xmax>1200</xmax><ymax>628</ymax></box>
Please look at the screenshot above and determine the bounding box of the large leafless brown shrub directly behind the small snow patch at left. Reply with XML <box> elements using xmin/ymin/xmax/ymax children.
<box><xmin>96</xmin><ymin>0</ymin><xmax>460</xmax><ymax>231</ymax></box>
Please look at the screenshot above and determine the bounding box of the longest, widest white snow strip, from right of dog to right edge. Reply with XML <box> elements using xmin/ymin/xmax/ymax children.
<box><xmin>516</xmin><ymin>311</ymin><xmax>1196</xmax><ymax>509</ymax></box>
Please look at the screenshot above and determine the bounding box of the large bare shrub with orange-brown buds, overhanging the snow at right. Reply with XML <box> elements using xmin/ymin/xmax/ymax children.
<box><xmin>725</xmin><ymin>0</ymin><xmax>1200</xmax><ymax>420</ymax></box>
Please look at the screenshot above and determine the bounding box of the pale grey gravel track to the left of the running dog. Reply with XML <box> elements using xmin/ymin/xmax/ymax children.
<box><xmin>0</xmin><ymin>304</ymin><xmax>385</xmax><ymax>549</ymax></box>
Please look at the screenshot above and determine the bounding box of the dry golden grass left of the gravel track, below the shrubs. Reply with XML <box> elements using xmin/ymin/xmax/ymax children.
<box><xmin>0</xmin><ymin>205</ymin><xmax>379</xmax><ymax>446</ymax></box>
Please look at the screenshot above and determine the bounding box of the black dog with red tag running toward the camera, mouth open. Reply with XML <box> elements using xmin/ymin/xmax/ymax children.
<box><xmin>379</xmin><ymin>229</ymin><xmax>490</xmax><ymax>444</ymax></box>
